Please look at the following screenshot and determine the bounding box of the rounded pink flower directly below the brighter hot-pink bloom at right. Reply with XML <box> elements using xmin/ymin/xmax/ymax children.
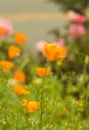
<box><xmin>69</xmin><ymin>24</ymin><xmax>87</xmax><ymax>38</ymax></box>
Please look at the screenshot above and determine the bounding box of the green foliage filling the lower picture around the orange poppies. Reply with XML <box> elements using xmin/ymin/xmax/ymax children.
<box><xmin>0</xmin><ymin>10</ymin><xmax>89</xmax><ymax>130</ymax></box>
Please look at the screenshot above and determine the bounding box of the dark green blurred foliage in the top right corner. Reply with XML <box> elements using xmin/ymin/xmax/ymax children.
<box><xmin>49</xmin><ymin>0</ymin><xmax>89</xmax><ymax>14</ymax></box>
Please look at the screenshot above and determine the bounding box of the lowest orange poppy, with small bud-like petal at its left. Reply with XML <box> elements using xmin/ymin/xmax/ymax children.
<box><xmin>23</xmin><ymin>99</ymin><xmax>40</xmax><ymax>113</ymax></box>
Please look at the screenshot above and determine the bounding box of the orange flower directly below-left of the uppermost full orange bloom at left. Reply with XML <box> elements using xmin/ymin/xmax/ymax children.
<box><xmin>8</xmin><ymin>45</ymin><xmax>21</xmax><ymax>58</ymax></box>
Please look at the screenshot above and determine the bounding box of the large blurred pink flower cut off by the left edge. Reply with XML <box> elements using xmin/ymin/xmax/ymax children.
<box><xmin>0</xmin><ymin>18</ymin><xmax>12</xmax><ymax>36</ymax></box>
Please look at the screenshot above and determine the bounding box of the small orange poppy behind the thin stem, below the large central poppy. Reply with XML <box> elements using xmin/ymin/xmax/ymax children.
<box><xmin>37</xmin><ymin>67</ymin><xmax>51</xmax><ymax>77</ymax></box>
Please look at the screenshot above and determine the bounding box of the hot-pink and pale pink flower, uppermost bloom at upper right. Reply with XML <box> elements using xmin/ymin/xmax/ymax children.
<box><xmin>68</xmin><ymin>11</ymin><xmax>86</xmax><ymax>23</ymax></box>
